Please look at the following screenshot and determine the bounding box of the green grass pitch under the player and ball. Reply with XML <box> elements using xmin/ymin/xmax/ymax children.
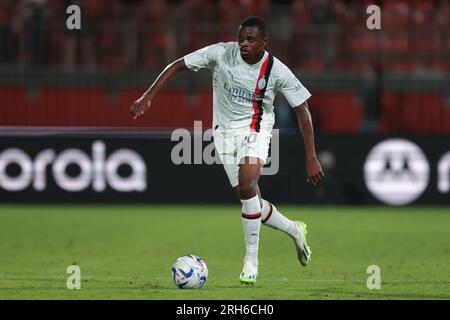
<box><xmin>0</xmin><ymin>204</ymin><xmax>450</xmax><ymax>300</ymax></box>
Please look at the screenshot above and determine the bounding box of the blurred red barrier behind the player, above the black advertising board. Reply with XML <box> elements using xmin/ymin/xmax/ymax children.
<box><xmin>0</xmin><ymin>87</ymin><xmax>450</xmax><ymax>134</ymax></box>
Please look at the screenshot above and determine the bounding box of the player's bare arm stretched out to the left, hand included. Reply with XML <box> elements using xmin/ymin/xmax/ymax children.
<box><xmin>130</xmin><ymin>58</ymin><xmax>188</xmax><ymax>119</ymax></box>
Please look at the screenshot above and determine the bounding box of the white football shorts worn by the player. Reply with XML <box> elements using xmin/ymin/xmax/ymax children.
<box><xmin>214</xmin><ymin>131</ymin><xmax>272</xmax><ymax>188</ymax></box>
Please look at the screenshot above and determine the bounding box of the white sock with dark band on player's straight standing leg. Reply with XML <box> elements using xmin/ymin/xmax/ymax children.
<box><xmin>241</xmin><ymin>195</ymin><xmax>261</xmax><ymax>269</ymax></box>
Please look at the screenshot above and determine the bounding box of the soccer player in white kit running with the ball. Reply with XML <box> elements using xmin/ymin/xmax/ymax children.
<box><xmin>130</xmin><ymin>17</ymin><xmax>324</xmax><ymax>284</ymax></box>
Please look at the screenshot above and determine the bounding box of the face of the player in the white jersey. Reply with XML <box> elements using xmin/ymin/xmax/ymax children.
<box><xmin>238</xmin><ymin>27</ymin><xmax>267</xmax><ymax>64</ymax></box>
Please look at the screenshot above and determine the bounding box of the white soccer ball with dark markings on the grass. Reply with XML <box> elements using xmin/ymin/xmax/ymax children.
<box><xmin>172</xmin><ymin>255</ymin><xmax>208</xmax><ymax>289</ymax></box>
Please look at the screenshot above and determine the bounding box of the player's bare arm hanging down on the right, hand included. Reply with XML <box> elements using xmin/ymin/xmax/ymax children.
<box><xmin>294</xmin><ymin>101</ymin><xmax>325</xmax><ymax>185</ymax></box>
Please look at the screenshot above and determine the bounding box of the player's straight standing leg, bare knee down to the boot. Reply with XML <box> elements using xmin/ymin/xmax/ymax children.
<box><xmin>238</xmin><ymin>157</ymin><xmax>263</xmax><ymax>283</ymax></box>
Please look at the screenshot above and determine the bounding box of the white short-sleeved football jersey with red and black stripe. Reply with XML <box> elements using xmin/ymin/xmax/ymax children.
<box><xmin>184</xmin><ymin>42</ymin><xmax>311</xmax><ymax>135</ymax></box>
